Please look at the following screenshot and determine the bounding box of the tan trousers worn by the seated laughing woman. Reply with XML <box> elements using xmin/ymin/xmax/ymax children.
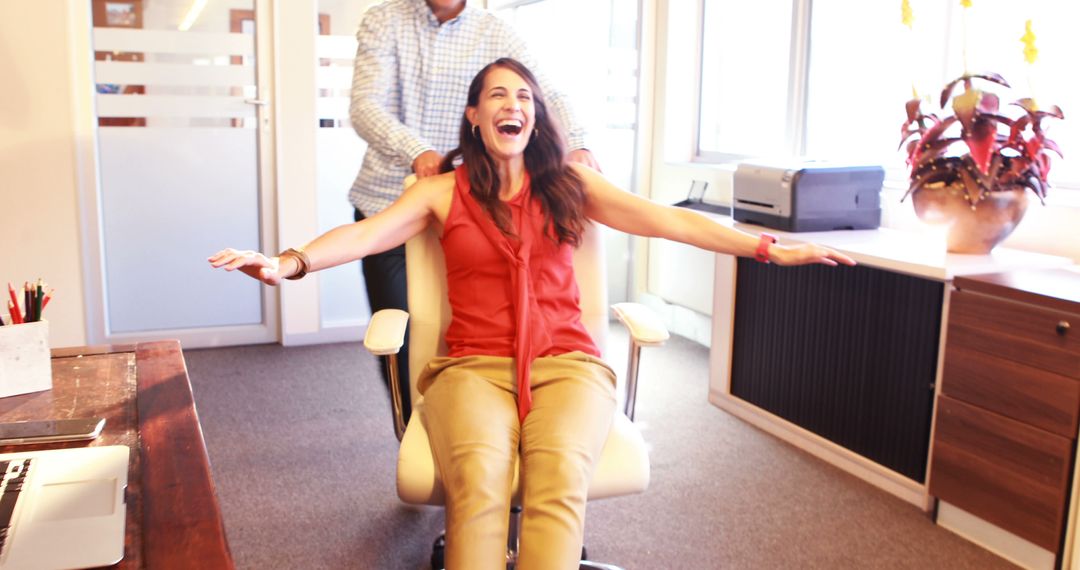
<box><xmin>418</xmin><ymin>352</ymin><xmax>616</xmax><ymax>570</ymax></box>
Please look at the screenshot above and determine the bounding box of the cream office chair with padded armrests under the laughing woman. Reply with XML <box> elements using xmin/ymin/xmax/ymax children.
<box><xmin>364</xmin><ymin>177</ymin><xmax>669</xmax><ymax>570</ymax></box>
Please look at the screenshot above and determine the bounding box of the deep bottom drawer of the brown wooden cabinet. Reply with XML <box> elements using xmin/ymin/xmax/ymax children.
<box><xmin>930</xmin><ymin>396</ymin><xmax>1072</xmax><ymax>553</ymax></box>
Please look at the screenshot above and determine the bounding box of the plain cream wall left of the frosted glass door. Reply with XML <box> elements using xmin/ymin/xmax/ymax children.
<box><xmin>0</xmin><ymin>0</ymin><xmax>86</xmax><ymax>347</ymax></box>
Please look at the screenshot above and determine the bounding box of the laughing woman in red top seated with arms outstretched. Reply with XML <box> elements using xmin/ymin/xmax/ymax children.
<box><xmin>210</xmin><ymin>59</ymin><xmax>854</xmax><ymax>570</ymax></box>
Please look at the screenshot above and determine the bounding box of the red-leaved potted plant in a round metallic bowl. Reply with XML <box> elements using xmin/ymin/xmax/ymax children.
<box><xmin>900</xmin><ymin>73</ymin><xmax>1065</xmax><ymax>254</ymax></box>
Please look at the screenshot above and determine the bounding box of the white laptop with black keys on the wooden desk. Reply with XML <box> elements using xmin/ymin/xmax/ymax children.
<box><xmin>0</xmin><ymin>446</ymin><xmax>129</xmax><ymax>570</ymax></box>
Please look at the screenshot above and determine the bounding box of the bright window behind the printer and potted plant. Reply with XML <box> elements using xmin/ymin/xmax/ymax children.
<box><xmin>698</xmin><ymin>0</ymin><xmax>1080</xmax><ymax>189</ymax></box>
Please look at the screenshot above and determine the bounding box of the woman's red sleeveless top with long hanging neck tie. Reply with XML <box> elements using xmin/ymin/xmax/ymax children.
<box><xmin>441</xmin><ymin>165</ymin><xmax>599</xmax><ymax>421</ymax></box>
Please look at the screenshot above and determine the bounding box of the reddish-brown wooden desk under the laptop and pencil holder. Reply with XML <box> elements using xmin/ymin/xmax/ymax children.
<box><xmin>0</xmin><ymin>341</ymin><xmax>233</xmax><ymax>569</ymax></box>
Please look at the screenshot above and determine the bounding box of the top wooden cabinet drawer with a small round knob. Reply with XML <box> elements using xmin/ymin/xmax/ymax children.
<box><xmin>947</xmin><ymin>290</ymin><xmax>1080</xmax><ymax>379</ymax></box>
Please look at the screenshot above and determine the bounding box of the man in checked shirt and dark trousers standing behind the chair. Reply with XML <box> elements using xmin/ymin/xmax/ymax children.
<box><xmin>349</xmin><ymin>0</ymin><xmax>599</xmax><ymax>422</ymax></box>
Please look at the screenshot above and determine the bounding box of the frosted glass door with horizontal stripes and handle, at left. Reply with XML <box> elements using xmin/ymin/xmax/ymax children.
<box><xmin>93</xmin><ymin>0</ymin><xmax>276</xmax><ymax>347</ymax></box>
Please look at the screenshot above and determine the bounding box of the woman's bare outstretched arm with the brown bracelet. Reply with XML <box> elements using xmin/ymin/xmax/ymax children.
<box><xmin>207</xmin><ymin>173</ymin><xmax>454</xmax><ymax>285</ymax></box>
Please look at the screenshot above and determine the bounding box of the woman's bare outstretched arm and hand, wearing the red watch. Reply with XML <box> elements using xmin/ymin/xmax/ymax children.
<box><xmin>572</xmin><ymin>165</ymin><xmax>855</xmax><ymax>266</ymax></box>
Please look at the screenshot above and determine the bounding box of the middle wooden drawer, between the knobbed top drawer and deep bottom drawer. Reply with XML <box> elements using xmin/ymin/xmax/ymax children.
<box><xmin>942</xmin><ymin>342</ymin><xmax>1080</xmax><ymax>438</ymax></box>
